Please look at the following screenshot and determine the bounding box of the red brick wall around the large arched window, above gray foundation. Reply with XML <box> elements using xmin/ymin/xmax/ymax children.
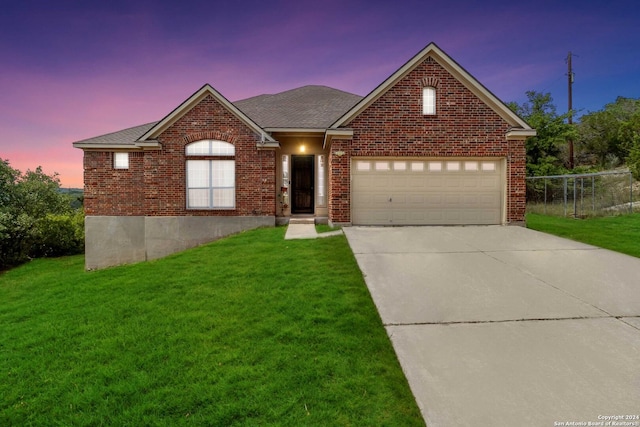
<box><xmin>85</xmin><ymin>96</ymin><xmax>276</xmax><ymax>216</ymax></box>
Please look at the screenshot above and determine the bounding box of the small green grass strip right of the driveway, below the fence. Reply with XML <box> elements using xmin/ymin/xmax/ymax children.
<box><xmin>527</xmin><ymin>214</ymin><xmax>640</xmax><ymax>257</ymax></box>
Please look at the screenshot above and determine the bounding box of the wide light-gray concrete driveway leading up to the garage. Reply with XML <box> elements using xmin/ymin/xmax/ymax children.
<box><xmin>344</xmin><ymin>226</ymin><xmax>640</xmax><ymax>427</ymax></box>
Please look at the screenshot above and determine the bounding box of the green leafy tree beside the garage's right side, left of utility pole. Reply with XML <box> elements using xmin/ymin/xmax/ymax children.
<box><xmin>509</xmin><ymin>91</ymin><xmax>577</xmax><ymax>176</ymax></box>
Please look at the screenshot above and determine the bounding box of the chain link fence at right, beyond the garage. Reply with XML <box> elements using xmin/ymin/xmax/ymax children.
<box><xmin>527</xmin><ymin>171</ymin><xmax>640</xmax><ymax>218</ymax></box>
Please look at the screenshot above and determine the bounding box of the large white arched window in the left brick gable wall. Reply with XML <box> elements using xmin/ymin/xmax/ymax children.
<box><xmin>185</xmin><ymin>139</ymin><xmax>236</xmax><ymax>209</ymax></box>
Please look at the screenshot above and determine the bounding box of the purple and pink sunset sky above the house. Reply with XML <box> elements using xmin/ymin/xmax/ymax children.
<box><xmin>0</xmin><ymin>0</ymin><xmax>640</xmax><ymax>187</ymax></box>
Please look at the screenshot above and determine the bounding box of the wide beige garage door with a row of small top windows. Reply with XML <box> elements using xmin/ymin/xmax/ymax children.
<box><xmin>351</xmin><ymin>158</ymin><xmax>504</xmax><ymax>225</ymax></box>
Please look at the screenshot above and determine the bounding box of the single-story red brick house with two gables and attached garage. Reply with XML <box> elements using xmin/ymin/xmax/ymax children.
<box><xmin>73</xmin><ymin>43</ymin><xmax>535</xmax><ymax>269</ymax></box>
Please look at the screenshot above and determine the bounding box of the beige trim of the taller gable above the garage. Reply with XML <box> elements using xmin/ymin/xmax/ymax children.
<box><xmin>330</xmin><ymin>43</ymin><xmax>535</xmax><ymax>137</ymax></box>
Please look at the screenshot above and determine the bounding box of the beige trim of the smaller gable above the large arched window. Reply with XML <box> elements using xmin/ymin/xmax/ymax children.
<box><xmin>138</xmin><ymin>83</ymin><xmax>276</xmax><ymax>142</ymax></box>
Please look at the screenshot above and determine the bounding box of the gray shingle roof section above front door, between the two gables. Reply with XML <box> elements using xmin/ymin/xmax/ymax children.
<box><xmin>233</xmin><ymin>86</ymin><xmax>362</xmax><ymax>129</ymax></box>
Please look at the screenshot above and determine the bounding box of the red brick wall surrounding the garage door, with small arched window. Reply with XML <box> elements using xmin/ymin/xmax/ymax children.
<box><xmin>330</xmin><ymin>58</ymin><xmax>525</xmax><ymax>222</ymax></box>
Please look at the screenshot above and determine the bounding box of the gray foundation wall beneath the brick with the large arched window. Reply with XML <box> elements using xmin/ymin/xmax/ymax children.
<box><xmin>85</xmin><ymin>216</ymin><xmax>275</xmax><ymax>270</ymax></box>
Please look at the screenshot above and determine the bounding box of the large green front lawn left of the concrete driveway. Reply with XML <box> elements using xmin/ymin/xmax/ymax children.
<box><xmin>0</xmin><ymin>227</ymin><xmax>424</xmax><ymax>426</ymax></box>
